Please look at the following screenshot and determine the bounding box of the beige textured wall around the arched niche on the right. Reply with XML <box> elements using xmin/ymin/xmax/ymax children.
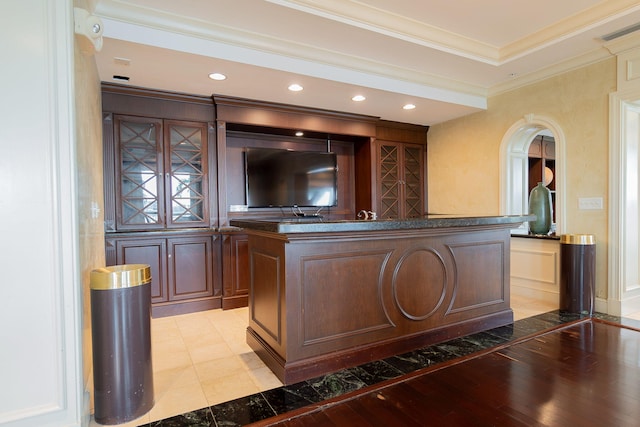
<box><xmin>428</xmin><ymin>58</ymin><xmax>616</xmax><ymax>299</ymax></box>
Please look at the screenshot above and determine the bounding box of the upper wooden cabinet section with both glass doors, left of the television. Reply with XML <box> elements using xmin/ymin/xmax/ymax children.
<box><xmin>103</xmin><ymin>84</ymin><xmax>217</xmax><ymax>231</ymax></box>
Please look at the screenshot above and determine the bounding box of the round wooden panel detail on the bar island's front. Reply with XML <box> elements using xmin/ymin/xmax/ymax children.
<box><xmin>392</xmin><ymin>249</ymin><xmax>447</xmax><ymax>320</ymax></box>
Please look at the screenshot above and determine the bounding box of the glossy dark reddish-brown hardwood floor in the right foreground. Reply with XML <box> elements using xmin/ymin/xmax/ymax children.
<box><xmin>253</xmin><ymin>318</ymin><xmax>640</xmax><ymax>427</ymax></box>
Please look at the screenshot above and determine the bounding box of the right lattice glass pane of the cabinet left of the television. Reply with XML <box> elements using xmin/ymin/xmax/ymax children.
<box><xmin>170</xmin><ymin>125</ymin><xmax>206</xmax><ymax>223</ymax></box>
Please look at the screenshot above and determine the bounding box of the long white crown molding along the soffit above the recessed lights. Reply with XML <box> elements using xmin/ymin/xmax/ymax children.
<box><xmin>96</xmin><ymin>0</ymin><xmax>487</xmax><ymax>108</ymax></box>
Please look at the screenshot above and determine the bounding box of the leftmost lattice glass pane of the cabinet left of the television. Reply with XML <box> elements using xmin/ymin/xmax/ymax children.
<box><xmin>119</xmin><ymin>121</ymin><xmax>162</xmax><ymax>225</ymax></box>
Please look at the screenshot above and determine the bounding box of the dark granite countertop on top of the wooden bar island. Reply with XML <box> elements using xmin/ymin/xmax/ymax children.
<box><xmin>230</xmin><ymin>215</ymin><xmax>535</xmax><ymax>234</ymax></box>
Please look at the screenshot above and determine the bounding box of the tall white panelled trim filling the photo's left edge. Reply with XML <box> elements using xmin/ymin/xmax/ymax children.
<box><xmin>0</xmin><ymin>0</ymin><xmax>84</xmax><ymax>426</ymax></box>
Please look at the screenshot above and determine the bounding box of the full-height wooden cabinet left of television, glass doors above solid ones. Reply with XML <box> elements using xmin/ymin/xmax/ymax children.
<box><xmin>102</xmin><ymin>84</ymin><xmax>222</xmax><ymax>317</ymax></box>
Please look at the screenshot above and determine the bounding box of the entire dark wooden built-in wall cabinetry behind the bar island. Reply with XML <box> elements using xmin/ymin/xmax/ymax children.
<box><xmin>102</xmin><ymin>83</ymin><xmax>428</xmax><ymax>315</ymax></box>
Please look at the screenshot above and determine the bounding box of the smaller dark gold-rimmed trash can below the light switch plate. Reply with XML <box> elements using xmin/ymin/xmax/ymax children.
<box><xmin>560</xmin><ymin>234</ymin><xmax>596</xmax><ymax>316</ymax></box>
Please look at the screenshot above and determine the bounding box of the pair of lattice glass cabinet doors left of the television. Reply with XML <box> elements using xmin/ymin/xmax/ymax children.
<box><xmin>114</xmin><ymin>115</ymin><xmax>208</xmax><ymax>230</ymax></box>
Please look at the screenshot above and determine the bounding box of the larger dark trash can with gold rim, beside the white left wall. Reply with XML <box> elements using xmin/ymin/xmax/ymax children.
<box><xmin>91</xmin><ymin>264</ymin><xmax>154</xmax><ymax>424</ymax></box>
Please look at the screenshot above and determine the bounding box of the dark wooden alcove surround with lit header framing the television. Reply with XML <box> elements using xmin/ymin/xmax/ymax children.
<box><xmin>214</xmin><ymin>95</ymin><xmax>377</xmax><ymax>226</ymax></box>
